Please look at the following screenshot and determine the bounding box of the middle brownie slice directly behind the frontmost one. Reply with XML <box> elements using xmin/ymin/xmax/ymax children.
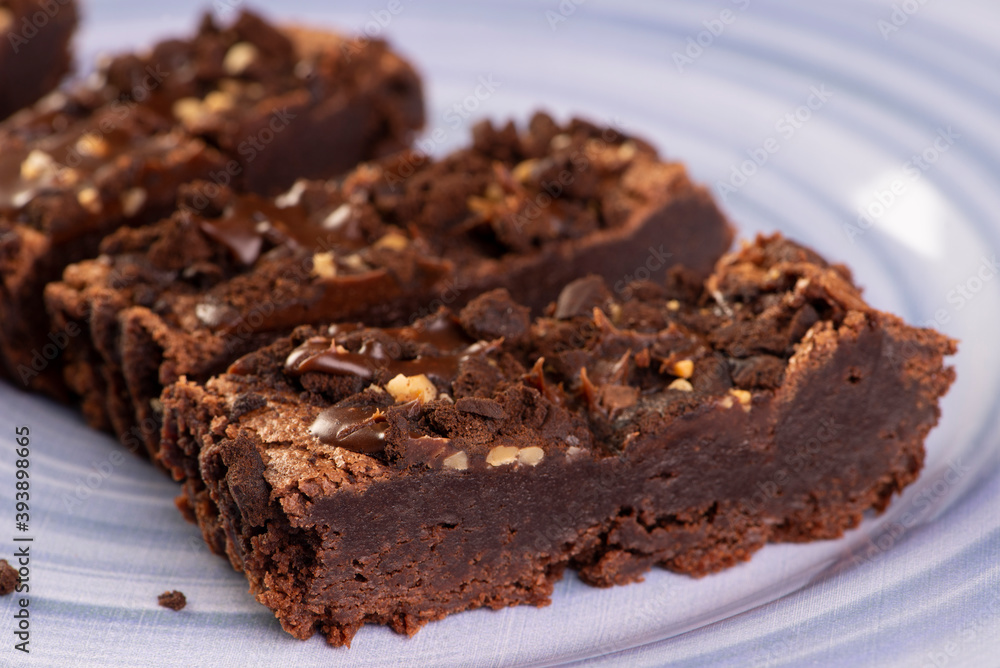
<box><xmin>47</xmin><ymin>114</ymin><xmax>732</xmax><ymax>459</ymax></box>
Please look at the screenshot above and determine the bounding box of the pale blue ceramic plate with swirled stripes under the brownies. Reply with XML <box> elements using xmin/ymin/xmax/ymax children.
<box><xmin>0</xmin><ymin>0</ymin><xmax>1000</xmax><ymax>667</ymax></box>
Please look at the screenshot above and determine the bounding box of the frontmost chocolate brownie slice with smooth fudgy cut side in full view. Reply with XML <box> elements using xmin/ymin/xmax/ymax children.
<box><xmin>163</xmin><ymin>236</ymin><xmax>955</xmax><ymax>645</ymax></box>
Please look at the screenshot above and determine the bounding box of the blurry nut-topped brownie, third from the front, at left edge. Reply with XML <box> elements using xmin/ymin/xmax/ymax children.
<box><xmin>0</xmin><ymin>12</ymin><xmax>423</xmax><ymax>396</ymax></box>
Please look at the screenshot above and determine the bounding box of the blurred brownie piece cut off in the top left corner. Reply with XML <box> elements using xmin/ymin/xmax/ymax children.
<box><xmin>0</xmin><ymin>0</ymin><xmax>77</xmax><ymax>120</ymax></box>
